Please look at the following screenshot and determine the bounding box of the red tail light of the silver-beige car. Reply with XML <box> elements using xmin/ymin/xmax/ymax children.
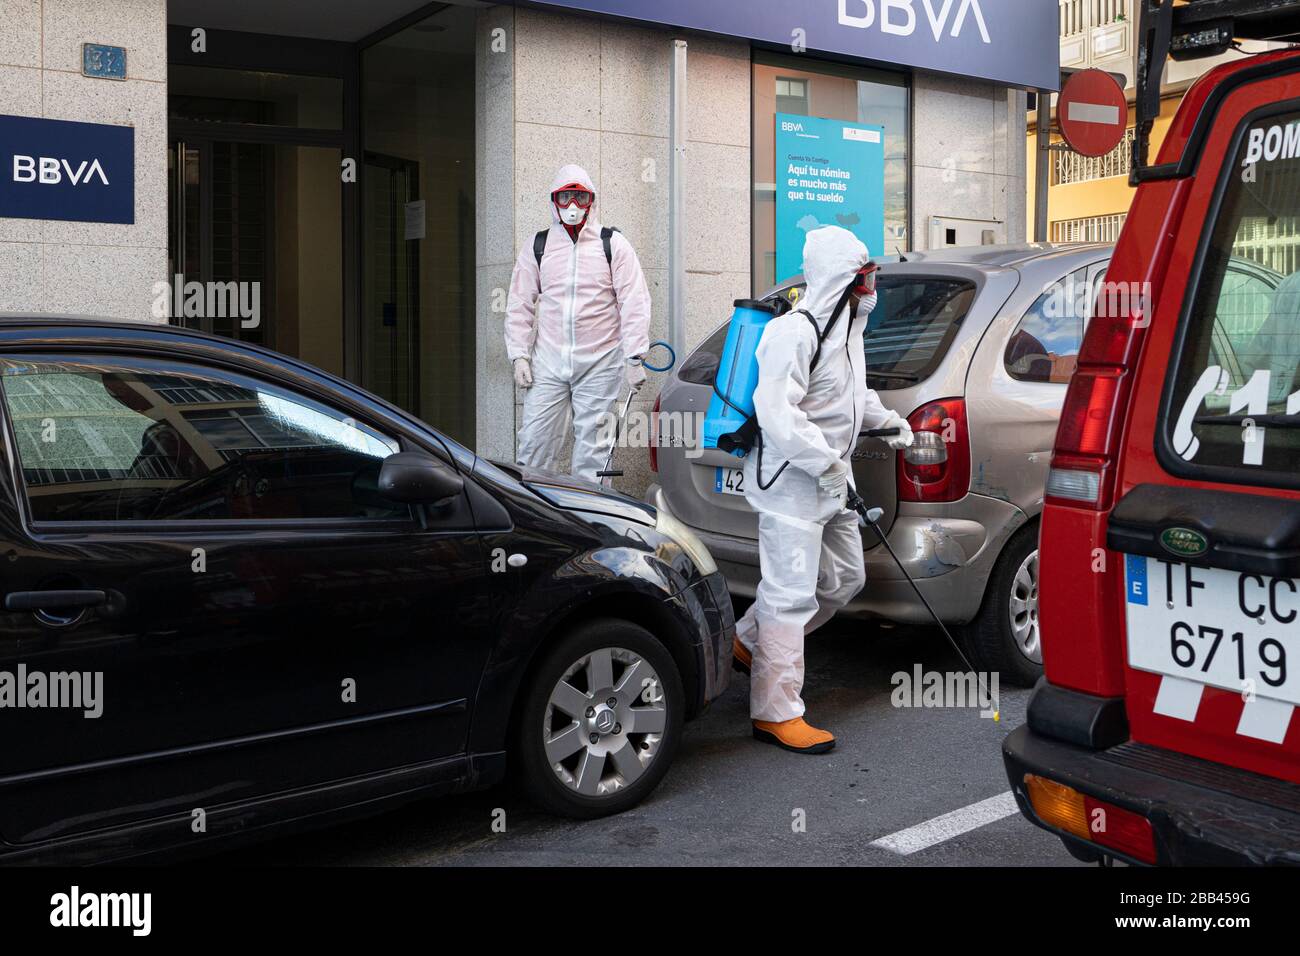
<box><xmin>898</xmin><ymin>398</ymin><xmax>971</xmax><ymax>502</ymax></box>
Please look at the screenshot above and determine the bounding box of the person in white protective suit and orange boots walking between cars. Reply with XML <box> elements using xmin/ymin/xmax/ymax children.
<box><xmin>735</xmin><ymin>226</ymin><xmax>913</xmax><ymax>753</ymax></box>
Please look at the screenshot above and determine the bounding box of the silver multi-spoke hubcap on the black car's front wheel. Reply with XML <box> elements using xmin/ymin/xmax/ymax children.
<box><xmin>542</xmin><ymin>648</ymin><xmax>667</xmax><ymax>796</ymax></box>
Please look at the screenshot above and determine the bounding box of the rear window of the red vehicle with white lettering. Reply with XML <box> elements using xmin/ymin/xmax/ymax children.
<box><xmin>1161</xmin><ymin>112</ymin><xmax>1300</xmax><ymax>486</ymax></box>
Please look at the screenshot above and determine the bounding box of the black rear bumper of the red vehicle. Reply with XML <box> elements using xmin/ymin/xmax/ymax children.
<box><xmin>1002</xmin><ymin>683</ymin><xmax>1300</xmax><ymax>866</ymax></box>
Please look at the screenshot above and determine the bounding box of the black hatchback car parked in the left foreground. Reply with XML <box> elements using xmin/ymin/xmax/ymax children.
<box><xmin>0</xmin><ymin>317</ymin><xmax>733</xmax><ymax>862</ymax></box>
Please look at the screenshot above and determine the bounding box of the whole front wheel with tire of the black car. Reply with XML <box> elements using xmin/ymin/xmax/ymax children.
<box><xmin>515</xmin><ymin>619</ymin><xmax>686</xmax><ymax>819</ymax></box>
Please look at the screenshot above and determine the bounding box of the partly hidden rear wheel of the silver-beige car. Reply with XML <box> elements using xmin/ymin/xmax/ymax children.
<box><xmin>963</xmin><ymin>522</ymin><xmax>1043</xmax><ymax>687</ymax></box>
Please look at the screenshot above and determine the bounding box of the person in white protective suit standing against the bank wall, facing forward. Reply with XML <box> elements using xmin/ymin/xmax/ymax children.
<box><xmin>506</xmin><ymin>165</ymin><xmax>650</xmax><ymax>481</ymax></box>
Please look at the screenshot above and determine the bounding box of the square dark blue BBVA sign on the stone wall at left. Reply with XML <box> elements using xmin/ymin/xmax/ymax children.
<box><xmin>0</xmin><ymin>116</ymin><xmax>135</xmax><ymax>222</ymax></box>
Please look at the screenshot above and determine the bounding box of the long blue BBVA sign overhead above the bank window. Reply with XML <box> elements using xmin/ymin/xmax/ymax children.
<box><xmin>524</xmin><ymin>0</ymin><xmax>1061</xmax><ymax>90</ymax></box>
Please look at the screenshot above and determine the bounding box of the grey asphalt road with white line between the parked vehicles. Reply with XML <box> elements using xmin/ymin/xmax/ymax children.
<box><xmin>213</xmin><ymin>622</ymin><xmax>1082</xmax><ymax>866</ymax></box>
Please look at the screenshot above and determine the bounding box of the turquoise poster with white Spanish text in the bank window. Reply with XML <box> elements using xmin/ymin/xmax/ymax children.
<box><xmin>776</xmin><ymin>113</ymin><xmax>885</xmax><ymax>282</ymax></box>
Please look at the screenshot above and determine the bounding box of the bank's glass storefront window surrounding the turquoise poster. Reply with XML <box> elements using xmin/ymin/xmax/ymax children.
<box><xmin>753</xmin><ymin>51</ymin><xmax>910</xmax><ymax>295</ymax></box>
